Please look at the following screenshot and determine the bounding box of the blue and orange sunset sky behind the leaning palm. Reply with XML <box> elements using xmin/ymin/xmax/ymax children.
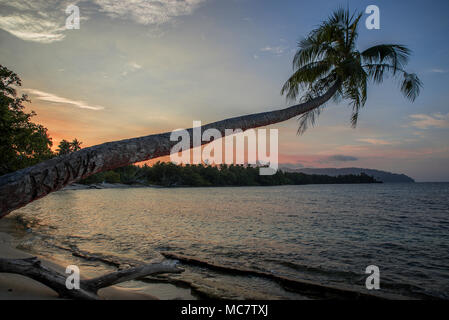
<box><xmin>0</xmin><ymin>0</ymin><xmax>449</xmax><ymax>181</ymax></box>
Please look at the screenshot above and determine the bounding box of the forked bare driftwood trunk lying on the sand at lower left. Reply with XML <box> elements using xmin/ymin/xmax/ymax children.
<box><xmin>0</xmin><ymin>257</ymin><xmax>184</xmax><ymax>300</ymax></box>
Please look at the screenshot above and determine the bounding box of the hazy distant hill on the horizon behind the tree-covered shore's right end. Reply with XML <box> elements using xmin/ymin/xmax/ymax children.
<box><xmin>280</xmin><ymin>165</ymin><xmax>415</xmax><ymax>183</ymax></box>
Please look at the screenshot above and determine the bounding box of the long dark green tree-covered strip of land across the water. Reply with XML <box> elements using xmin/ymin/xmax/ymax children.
<box><xmin>81</xmin><ymin>162</ymin><xmax>378</xmax><ymax>187</ymax></box>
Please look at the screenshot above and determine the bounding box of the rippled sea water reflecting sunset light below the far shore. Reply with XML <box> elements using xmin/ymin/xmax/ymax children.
<box><xmin>6</xmin><ymin>183</ymin><xmax>449</xmax><ymax>299</ymax></box>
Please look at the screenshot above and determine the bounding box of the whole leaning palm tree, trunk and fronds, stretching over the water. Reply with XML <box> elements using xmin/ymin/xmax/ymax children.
<box><xmin>0</xmin><ymin>9</ymin><xmax>421</xmax><ymax>217</ymax></box>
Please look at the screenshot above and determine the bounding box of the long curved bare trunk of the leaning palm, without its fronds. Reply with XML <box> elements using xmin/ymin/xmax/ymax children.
<box><xmin>0</xmin><ymin>82</ymin><xmax>339</xmax><ymax>218</ymax></box>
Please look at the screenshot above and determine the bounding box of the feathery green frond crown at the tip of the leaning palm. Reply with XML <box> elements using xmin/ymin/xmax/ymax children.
<box><xmin>281</xmin><ymin>9</ymin><xmax>422</xmax><ymax>134</ymax></box>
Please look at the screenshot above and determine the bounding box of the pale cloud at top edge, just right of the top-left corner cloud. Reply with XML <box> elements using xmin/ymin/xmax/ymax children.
<box><xmin>93</xmin><ymin>0</ymin><xmax>205</xmax><ymax>25</ymax></box>
